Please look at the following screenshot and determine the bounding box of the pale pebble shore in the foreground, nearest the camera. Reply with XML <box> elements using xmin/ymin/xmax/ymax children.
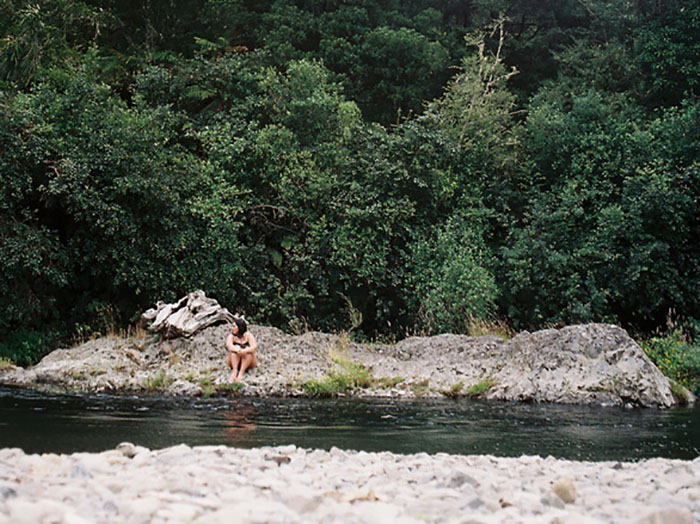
<box><xmin>0</xmin><ymin>443</ymin><xmax>700</xmax><ymax>524</ymax></box>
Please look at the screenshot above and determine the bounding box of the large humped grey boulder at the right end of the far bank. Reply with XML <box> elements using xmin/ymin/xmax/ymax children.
<box><xmin>490</xmin><ymin>324</ymin><xmax>676</xmax><ymax>408</ymax></box>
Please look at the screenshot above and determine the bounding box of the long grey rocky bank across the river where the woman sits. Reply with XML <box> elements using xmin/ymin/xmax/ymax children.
<box><xmin>0</xmin><ymin>324</ymin><xmax>693</xmax><ymax>408</ymax></box>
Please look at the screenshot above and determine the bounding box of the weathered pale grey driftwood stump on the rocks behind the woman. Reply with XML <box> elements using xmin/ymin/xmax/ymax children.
<box><xmin>141</xmin><ymin>290</ymin><xmax>234</xmax><ymax>338</ymax></box>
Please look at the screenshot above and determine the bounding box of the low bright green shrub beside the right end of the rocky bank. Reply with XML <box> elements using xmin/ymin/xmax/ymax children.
<box><xmin>641</xmin><ymin>329</ymin><xmax>700</xmax><ymax>393</ymax></box>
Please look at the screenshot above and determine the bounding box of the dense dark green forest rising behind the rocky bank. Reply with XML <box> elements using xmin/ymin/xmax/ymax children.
<box><xmin>0</xmin><ymin>0</ymin><xmax>700</xmax><ymax>379</ymax></box>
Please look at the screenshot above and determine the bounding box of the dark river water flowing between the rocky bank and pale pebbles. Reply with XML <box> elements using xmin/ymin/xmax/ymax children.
<box><xmin>0</xmin><ymin>388</ymin><xmax>700</xmax><ymax>460</ymax></box>
